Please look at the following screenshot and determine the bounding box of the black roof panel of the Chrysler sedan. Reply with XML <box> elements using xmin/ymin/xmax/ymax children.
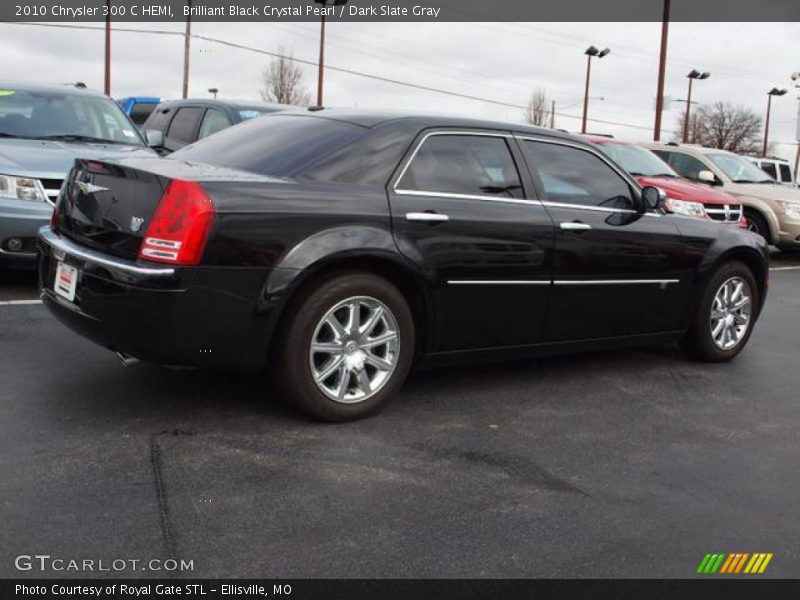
<box><xmin>276</xmin><ymin>108</ymin><xmax>577</xmax><ymax>140</ymax></box>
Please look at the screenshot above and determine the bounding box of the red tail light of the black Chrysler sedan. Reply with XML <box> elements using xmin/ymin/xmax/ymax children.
<box><xmin>139</xmin><ymin>179</ymin><xmax>214</xmax><ymax>265</ymax></box>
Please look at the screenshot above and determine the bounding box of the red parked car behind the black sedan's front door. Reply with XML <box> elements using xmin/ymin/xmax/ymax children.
<box><xmin>583</xmin><ymin>135</ymin><xmax>747</xmax><ymax>228</ymax></box>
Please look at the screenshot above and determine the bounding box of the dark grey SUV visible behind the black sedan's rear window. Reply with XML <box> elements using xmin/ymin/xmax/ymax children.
<box><xmin>142</xmin><ymin>98</ymin><xmax>289</xmax><ymax>155</ymax></box>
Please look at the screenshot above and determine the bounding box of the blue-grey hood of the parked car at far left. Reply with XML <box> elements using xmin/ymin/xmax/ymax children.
<box><xmin>0</xmin><ymin>138</ymin><xmax>156</xmax><ymax>179</ymax></box>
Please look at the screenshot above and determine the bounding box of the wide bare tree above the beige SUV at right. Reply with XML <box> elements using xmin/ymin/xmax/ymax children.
<box><xmin>679</xmin><ymin>102</ymin><xmax>761</xmax><ymax>154</ymax></box>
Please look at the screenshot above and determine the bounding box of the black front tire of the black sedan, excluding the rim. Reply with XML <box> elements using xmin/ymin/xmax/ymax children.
<box><xmin>682</xmin><ymin>261</ymin><xmax>761</xmax><ymax>362</ymax></box>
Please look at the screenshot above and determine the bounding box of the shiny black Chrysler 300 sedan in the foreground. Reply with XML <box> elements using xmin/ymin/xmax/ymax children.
<box><xmin>39</xmin><ymin>110</ymin><xmax>768</xmax><ymax>420</ymax></box>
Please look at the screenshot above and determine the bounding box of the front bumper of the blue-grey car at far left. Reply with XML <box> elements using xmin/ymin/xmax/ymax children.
<box><xmin>0</xmin><ymin>198</ymin><xmax>53</xmax><ymax>269</ymax></box>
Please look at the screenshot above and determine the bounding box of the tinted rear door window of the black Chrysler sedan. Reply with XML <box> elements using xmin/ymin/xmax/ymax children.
<box><xmin>396</xmin><ymin>134</ymin><xmax>524</xmax><ymax>198</ymax></box>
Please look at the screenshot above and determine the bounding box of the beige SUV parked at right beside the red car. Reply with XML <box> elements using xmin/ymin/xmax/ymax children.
<box><xmin>645</xmin><ymin>144</ymin><xmax>800</xmax><ymax>252</ymax></box>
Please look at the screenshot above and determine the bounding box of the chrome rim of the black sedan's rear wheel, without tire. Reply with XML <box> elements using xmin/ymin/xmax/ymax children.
<box><xmin>309</xmin><ymin>296</ymin><xmax>400</xmax><ymax>404</ymax></box>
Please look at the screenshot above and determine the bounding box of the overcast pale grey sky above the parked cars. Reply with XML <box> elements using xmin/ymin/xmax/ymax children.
<box><xmin>0</xmin><ymin>22</ymin><xmax>800</xmax><ymax>160</ymax></box>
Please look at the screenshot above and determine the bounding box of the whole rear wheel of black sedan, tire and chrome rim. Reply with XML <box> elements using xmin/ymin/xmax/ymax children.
<box><xmin>274</xmin><ymin>272</ymin><xmax>414</xmax><ymax>421</ymax></box>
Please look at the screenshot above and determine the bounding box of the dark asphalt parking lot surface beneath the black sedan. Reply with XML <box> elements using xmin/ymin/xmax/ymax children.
<box><xmin>0</xmin><ymin>255</ymin><xmax>800</xmax><ymax>578</ymax></box>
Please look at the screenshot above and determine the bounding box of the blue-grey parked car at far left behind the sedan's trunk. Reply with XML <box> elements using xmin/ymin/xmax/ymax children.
<box><xmin>0</xmin><ymin>82</ymin><xmax>159</xmax><ymax>268</ymax></box>
